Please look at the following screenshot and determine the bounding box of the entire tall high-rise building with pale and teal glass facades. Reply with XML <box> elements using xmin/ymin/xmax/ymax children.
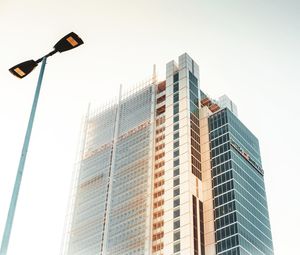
<box><xmin>64</xmin><ymin>54</ymin><xmax>273</xmax><ymax>255</ymax></box>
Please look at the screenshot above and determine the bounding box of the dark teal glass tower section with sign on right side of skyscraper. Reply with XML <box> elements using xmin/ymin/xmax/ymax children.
<box><xmin>209</xmin><ymin>108</ymin><xmax>273</xmax><ymax>254</ymax></box>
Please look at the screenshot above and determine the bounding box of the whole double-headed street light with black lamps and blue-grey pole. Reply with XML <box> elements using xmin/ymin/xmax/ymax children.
<box><xmin>0</xmin><ymin>32</ymin><xmax>83</xmax><ymax>255</ymax></box>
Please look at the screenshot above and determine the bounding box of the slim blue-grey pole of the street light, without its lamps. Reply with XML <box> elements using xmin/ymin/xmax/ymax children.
<box><xmin>0</xmin><ymin>57</ymin><xmax>47</xmax><ymax>255</ymax></box>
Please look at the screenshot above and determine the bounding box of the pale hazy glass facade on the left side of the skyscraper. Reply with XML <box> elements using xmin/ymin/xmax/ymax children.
<box><xmin>63</xmin><ymin>86</ymin><xmax>153</xmax><ymax>255</ymax></box>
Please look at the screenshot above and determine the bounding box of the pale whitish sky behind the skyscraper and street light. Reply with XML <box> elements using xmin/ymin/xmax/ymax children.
<box><xmin>0</xmin><ymin>0</ymin><xmax>300</xmax><ymax>255</ymax></box>
